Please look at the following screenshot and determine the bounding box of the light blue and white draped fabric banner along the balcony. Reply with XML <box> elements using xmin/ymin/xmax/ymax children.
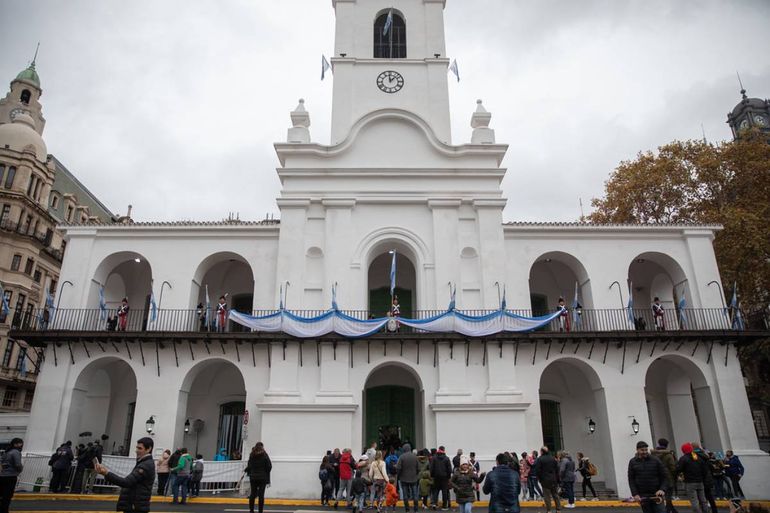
<box><xmin>225</xmin><ymin>310</ymin><xmax>562</xmax><ymax>338</ymax></box>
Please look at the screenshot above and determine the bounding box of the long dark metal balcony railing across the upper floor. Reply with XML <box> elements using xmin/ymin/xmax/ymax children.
<box><xmin>0</xmin><ymin>308</ymin><xmax>770</xmax><ymax>333</ymax></box>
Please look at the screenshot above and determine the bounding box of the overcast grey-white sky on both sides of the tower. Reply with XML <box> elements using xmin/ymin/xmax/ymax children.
<box><xmin>0</xmin><ymin>0</ymin><xmax>770</xmax><ymax>221</ymax></box>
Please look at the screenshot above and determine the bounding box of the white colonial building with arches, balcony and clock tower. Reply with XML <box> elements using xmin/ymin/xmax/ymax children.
<box><xmin>16</xmin><ymin>0</ymin><xmax>770</xmax><ymax>497</ymax></box>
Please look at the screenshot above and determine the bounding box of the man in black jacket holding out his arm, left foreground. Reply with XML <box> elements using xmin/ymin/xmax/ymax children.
<box><xmin>94</xmin><ymin>437</ymin><xmax>155</xmax><ymax>512</ymax></box>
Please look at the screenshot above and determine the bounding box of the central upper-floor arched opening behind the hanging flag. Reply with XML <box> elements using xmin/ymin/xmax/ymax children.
<box><xmin>368</xmin><ymin>246</ymin><xmax>417</xmax><ymax>317</ymax></box>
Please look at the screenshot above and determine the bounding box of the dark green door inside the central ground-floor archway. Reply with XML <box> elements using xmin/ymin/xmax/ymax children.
<box><xmin>364</xmin><ymin>385</ymin><xmax>416</xmax><ymax>449</ymax></box>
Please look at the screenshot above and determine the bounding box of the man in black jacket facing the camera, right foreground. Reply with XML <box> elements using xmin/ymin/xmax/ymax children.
<box><xmin>628</xmin><ymin>442</ymin><xmax>669</xmax><ymax>513</ymax></box>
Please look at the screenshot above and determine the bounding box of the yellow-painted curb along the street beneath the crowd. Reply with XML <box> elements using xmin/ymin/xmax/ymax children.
<box><xmin>14</xmin><ymin>493</ymin><xmax>770</xmax><ymax>511</ymax></box>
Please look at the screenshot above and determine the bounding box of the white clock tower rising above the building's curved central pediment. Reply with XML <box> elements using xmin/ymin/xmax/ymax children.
<box><xmin>331</xmin><ymin>0</ymin><xmax>451</xmax><ymax>144</ymax></box>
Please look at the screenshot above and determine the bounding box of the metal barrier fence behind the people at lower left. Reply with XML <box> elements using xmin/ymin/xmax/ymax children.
<box><xmin>16</xmin><ymin>453</ymin><xmax>246</xmax><ymax>495</ymax></box>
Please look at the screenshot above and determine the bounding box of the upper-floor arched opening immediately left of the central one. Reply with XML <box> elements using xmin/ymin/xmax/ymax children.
<box><xmin>190</xmin><ymin>252</ymin><xmax>254</xmax><ymax>331</ymax></box>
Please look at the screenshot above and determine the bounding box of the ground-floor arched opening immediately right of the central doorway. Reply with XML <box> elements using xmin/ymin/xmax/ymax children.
<box><xmin>540</xmin><ymin>358</ymin><xmax>617</xmax><ymax>487</ymax></box>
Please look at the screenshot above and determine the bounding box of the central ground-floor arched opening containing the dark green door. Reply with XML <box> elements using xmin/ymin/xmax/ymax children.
<box><xmin>363</xmin><ymin>363</ymin><xmax>425</xmax><ymax>450</ymax></box>
